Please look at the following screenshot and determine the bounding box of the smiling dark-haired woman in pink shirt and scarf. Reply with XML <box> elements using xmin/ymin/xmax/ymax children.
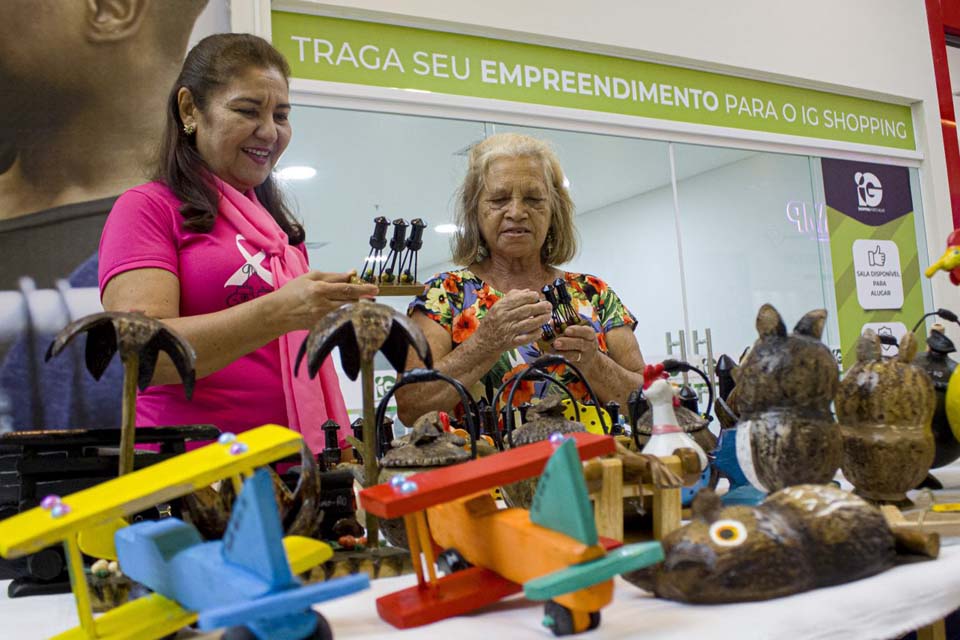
<box><xmin>99</xmin><ymin>34</ymin><xmax>377</xmax><ymax>452</ymax></box>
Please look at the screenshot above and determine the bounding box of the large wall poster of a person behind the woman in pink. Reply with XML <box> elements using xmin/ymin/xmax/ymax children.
<box><xmin>0</xmin><ymin>0</ymin><xmax>230</xmax><ymax>430</ymax></box>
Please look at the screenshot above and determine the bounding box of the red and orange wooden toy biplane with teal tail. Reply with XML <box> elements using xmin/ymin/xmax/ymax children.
<box><xmin>360</xmin><ymin>433</ymin><xmax>663</xmax><ymax>635</ymax></box>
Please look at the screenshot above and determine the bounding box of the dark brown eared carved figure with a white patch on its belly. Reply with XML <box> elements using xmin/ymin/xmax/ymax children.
<box><xmin>730</xmin><ymin>304</ymin><xmax>842</xmax><ymax>492</ymax></box>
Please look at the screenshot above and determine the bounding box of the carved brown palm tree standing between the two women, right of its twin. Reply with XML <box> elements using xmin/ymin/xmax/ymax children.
<box><xmin>294</xmin><ymin>300</ymin><xmax>433</xmax><ymax>547</ymax></box>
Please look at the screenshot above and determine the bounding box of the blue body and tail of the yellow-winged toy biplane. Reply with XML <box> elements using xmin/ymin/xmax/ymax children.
<box><xmin>115</xmin><ymin>469</ymin><xmax>369</xmax><ymax>640</ymax></box>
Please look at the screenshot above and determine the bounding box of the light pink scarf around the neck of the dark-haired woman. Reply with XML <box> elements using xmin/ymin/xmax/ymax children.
<box><xmin>214</xmin><ymin>177</ymin><xmax>349</xmax><ymax>454</ymax></box>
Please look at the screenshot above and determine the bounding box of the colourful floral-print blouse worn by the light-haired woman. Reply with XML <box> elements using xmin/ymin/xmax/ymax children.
<box><xmin>407</xmin><ymin>269</ymin><xmax>637</xmax><ymax>405</ymax></box>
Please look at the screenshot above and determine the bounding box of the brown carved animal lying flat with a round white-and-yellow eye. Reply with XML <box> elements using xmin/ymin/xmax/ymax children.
<box><xmin>623</xmin><ymin>485</ymin><xmax>939</xmax><ymax>604</ymax></box>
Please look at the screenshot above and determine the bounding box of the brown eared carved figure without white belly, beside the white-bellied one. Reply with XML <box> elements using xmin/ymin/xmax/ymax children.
<box><xmin>835</xmin><ymin>331</ymin><xmax>936</xmax><ymax>504</ymax></box>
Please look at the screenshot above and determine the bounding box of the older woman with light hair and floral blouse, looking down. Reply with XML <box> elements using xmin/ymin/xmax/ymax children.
<box><xmin>397</xmin><ymin>134</ymin><xmax>644</xmax><ymax>424</ymax></box>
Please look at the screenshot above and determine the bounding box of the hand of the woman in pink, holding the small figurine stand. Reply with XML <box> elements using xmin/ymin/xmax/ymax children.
<box><xmin>271</xmin><ymin>271</ymin><xmax>379</xmax><ymax>333</ymax></box>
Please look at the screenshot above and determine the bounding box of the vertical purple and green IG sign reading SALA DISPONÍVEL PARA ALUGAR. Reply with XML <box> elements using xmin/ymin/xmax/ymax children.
<box><xmin>821</xmin><ymin>158</ymin><xmax>924</xmax><ymax>369</ymax></box>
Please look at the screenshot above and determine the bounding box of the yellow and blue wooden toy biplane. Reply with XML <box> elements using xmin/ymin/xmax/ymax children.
<box><xmin>0</xmin><ymin>425</ymin><xmax>368</xmax><ymax>640</ymax></box>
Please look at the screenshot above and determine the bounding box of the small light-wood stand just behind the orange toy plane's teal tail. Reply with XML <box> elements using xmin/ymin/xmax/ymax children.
<box><xmin>590</xmin><ymin>456</ymin><xmax>683</xmax><ymax>541</ymax></box>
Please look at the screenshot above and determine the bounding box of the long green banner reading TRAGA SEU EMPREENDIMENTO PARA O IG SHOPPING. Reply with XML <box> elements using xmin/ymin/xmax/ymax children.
<box><xmin>272</xmin><ymin>11</ymin><xmax>916</xmax><ymax>150</ymax></box>
